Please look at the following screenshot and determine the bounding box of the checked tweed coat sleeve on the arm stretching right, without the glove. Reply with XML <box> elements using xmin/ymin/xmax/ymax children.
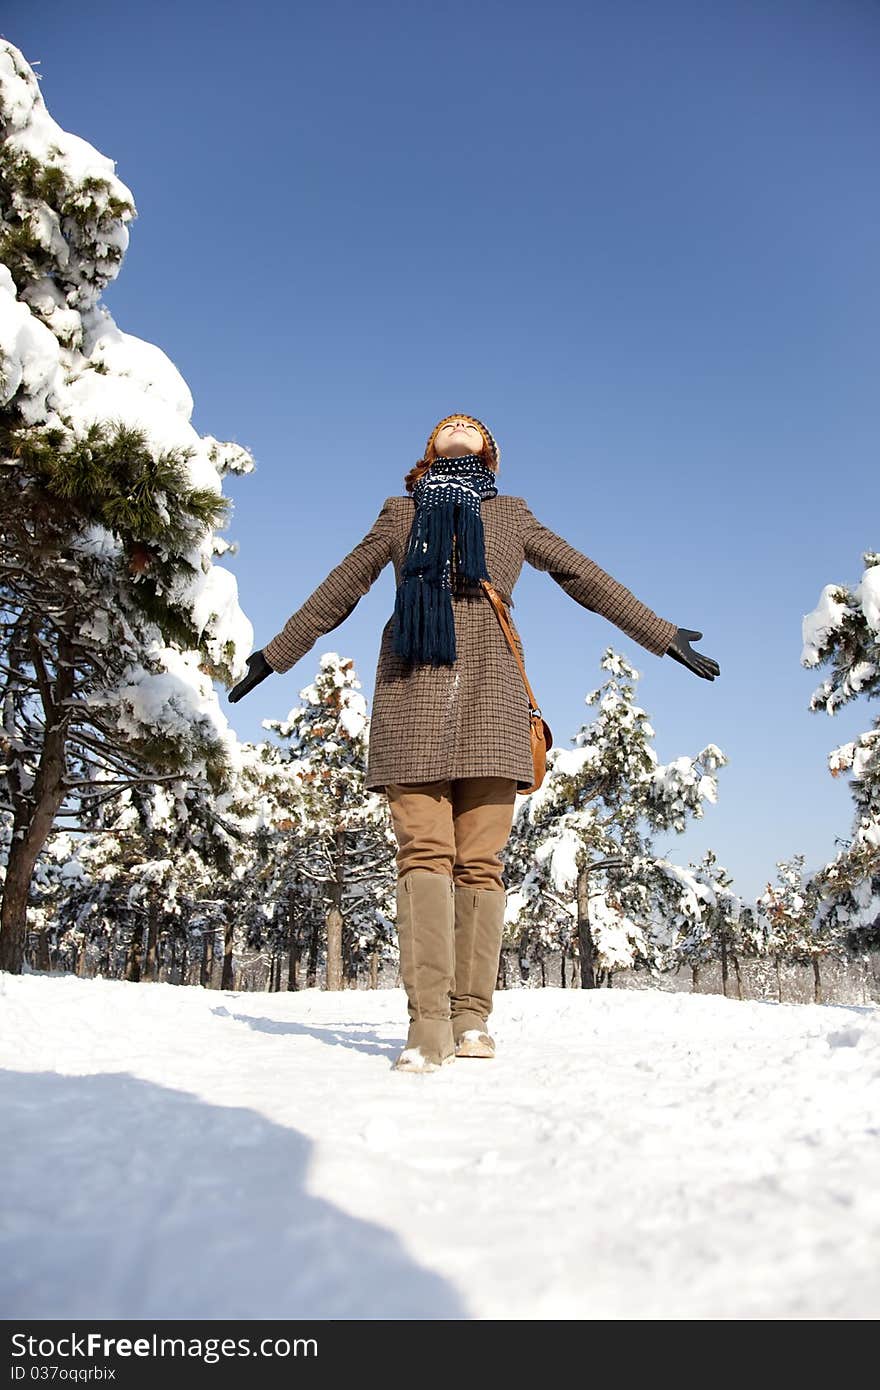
<box><xmin>520</xmin><ymin>499</ymin><xmax>678</xmax><ymax>656</ymax></box>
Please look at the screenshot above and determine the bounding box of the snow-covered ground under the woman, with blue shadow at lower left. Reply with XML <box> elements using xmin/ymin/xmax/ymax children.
<box><xmin>0</xmin><ymin>974</ymin><xmax>880</xmax><ymax>1319</ymax></box>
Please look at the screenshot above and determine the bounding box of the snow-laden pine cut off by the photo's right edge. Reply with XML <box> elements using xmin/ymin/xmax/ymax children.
<box><xmin>801</xmin><ymin>550</ymin><xmax>880</xmax><ymax>952</ymax></box>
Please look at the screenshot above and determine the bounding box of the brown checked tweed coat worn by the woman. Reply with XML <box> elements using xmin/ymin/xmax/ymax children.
<box><xmin>263</xmin><ymin>492</ymin><xmax>676</xmax><ymax>791</ymax></box>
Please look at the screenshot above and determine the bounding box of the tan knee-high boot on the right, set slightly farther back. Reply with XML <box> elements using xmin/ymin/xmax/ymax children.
<box><xmin>452</xmin><ymin>885</ymin><xmax>507</xmax><ymax>1056</ymax></box>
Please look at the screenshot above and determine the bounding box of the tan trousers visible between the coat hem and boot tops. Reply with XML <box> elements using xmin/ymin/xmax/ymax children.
<box><xmin>385</xmin><ymin>777</ymin><xmax>517</xmax><ymax>892</ymax></box>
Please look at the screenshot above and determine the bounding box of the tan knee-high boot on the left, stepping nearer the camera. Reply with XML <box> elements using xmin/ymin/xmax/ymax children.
<box><xmin>395</xmin><ymin>869</ymin><xmax>455</xmax><ymax>1072</ymax></box>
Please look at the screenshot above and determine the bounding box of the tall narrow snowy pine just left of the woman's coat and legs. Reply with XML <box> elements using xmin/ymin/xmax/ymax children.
<box><xmin>263</xmin><ymin>652</ymin><xmax>396</xmax><ymax>990</ymax></box>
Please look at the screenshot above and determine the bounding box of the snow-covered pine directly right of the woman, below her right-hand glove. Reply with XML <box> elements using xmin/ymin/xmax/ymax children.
<box><xmin>505</xmin><ymin>646</ymin><xmax>727</xmax><ymax>988</ymax></box>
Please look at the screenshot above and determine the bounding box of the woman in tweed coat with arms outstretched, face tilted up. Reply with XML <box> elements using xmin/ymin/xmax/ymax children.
<box><xmin>229</xmin><ymin>416</ymin><xmax>720</xmax><ymax>1072</ymax></box>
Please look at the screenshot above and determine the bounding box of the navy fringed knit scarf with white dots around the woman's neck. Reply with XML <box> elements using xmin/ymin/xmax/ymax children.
<box><xmin>395</xmin><ymin>453</ymin><xmax>498</xmax><ymax>666</ymax></box>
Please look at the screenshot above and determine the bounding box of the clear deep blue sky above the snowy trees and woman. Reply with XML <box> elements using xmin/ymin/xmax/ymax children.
<box><xmin>3</xmin><ymin>0</ymin><xmax>880</xmax><ymax>895</ymax></box>
